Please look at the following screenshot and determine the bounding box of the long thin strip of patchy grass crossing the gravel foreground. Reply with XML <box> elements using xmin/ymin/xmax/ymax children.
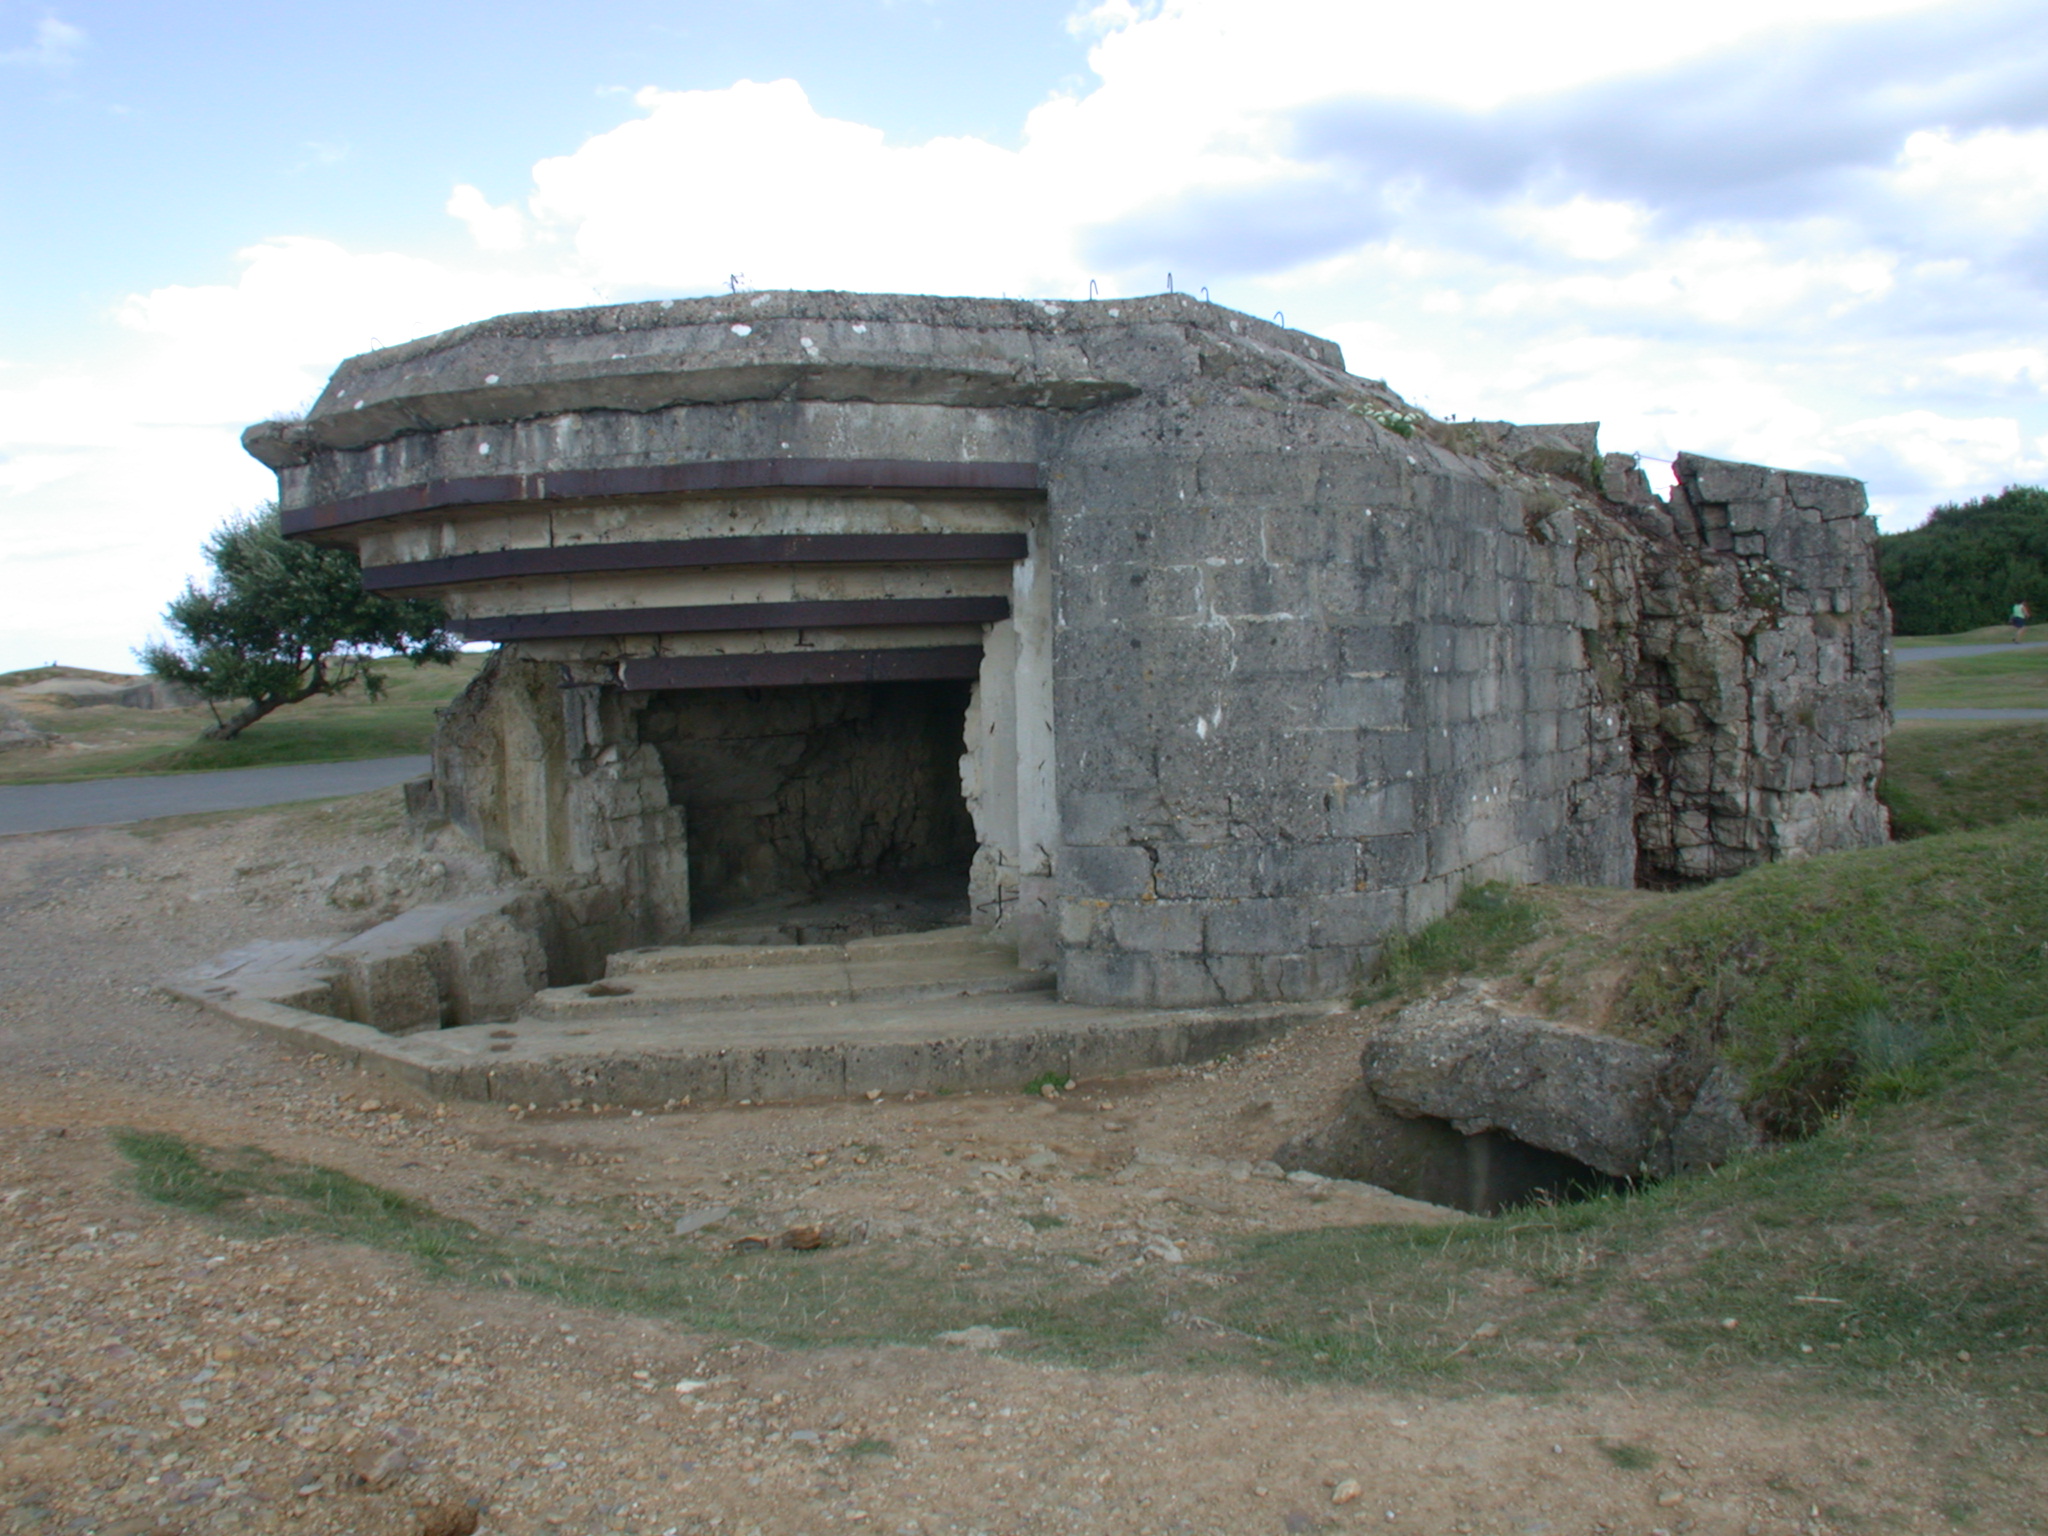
<box><xmin>119</xmin><ymin>1055</ymin><xmax>2048</xmax><ymax>1409</ymax></box>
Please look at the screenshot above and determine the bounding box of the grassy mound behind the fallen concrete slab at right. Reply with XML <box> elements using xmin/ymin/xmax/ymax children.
<box><xmin>1610</xmin><ymin>821</ymin><xmax>2048</xmax><ymax>1135</ymax></box>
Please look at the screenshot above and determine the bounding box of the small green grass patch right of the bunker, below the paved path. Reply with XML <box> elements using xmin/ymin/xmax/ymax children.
<box><xmin>1878</xmin><ymin>723</ymin><xmax>2048</xmax><ymax>838</ymax></box>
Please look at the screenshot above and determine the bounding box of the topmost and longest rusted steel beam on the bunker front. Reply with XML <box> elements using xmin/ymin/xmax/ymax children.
<box><xmin>279</xmin><ymin>459</ymin><xmax>1044</xmax><ymax>539</ymax></box>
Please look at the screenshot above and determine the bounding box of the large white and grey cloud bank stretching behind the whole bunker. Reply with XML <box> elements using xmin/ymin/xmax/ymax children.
<box><xmin>0</xmin><ymin>0</ymin><xmax>2048</xmax><ymax>664</ymax></box>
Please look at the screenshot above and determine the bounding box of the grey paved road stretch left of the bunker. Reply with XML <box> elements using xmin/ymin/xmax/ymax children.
<box><xmin>0</xmin><ymin>756</ymin><xmax>432</xmax><ymax>836</ymax></box>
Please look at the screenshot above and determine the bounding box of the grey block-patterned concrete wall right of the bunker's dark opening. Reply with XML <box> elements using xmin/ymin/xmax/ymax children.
<box><xmin>1049</xmin><ymin>391</ymin><xmax>1632</xmax><ymax>1006</ymax></box>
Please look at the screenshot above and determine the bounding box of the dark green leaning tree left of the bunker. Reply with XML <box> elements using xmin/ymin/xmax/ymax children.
<box><xmin>137</xmin><ymin>504</ymin><xmax>455</xmax><ymax>741</ymax></box>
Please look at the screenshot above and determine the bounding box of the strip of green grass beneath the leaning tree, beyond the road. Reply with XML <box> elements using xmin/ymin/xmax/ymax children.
<box><xmin>0</xmin><ymin>655</ymin><xmax>483</xmax><ymax>784</ymax></box>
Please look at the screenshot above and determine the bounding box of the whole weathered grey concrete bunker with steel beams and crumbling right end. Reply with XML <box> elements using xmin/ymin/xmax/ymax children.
<box><xmin>244</xmin><ymin>293</ymin><xmax>1888</xmax><ymax>1028</ymax></box>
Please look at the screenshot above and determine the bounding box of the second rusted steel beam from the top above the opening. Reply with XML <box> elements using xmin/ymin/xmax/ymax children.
<box><xmin>362</xmin><ymin>532</ymin><xmax>1030</xmax><ymax>592</ymax></box>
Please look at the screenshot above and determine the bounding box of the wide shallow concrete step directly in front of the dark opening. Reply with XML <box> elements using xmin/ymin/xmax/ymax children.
<box><xmin>522</xmin><ymin>930</ymin><xmax>1055</xmax><ymax>1020</ymax></box>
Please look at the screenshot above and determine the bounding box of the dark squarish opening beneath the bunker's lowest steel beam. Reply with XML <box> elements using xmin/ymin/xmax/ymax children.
<box><xmin>639</xmin><ymin>678</ymin><xmax>975</xmax><ymax>944</ymax></box>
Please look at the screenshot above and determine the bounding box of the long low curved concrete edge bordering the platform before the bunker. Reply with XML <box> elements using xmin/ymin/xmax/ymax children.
<box><xmin>166</xmin><ymin>983</ymin><xmax>1343</xmax><ymax>1110</ymax></box>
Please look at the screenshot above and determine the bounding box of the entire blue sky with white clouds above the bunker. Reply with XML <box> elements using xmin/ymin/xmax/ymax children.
<box><xmin>0</xmin><ymin>0</ymin><xmax>2048</xmax><ymax>670</ymax></box>
